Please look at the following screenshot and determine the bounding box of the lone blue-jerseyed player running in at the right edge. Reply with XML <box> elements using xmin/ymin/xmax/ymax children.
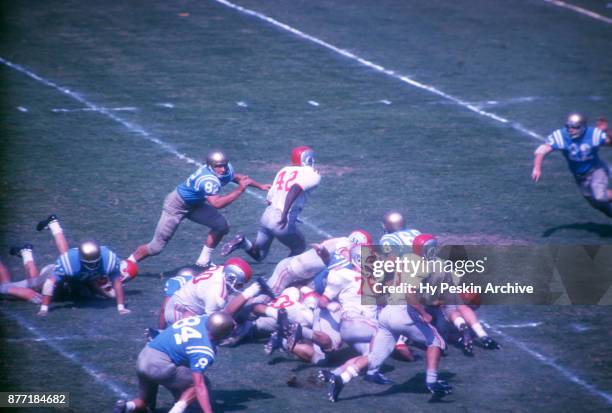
<box><xmin>531</xmin><ymin>112</ymin><xmax>612</xmax><ymax>217</ymax></box>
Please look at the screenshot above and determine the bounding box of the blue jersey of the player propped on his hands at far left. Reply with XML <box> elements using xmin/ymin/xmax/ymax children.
<box><xmin>53</xmin><ymin>246</ymin><xmax>120</xmax><ymax>281</ymax></box>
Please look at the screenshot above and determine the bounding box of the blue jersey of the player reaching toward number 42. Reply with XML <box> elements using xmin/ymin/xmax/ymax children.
<box><xmin>176</xmin><ymin>163</ymin><xmax>234</xmax><ymax>205</ymax></box>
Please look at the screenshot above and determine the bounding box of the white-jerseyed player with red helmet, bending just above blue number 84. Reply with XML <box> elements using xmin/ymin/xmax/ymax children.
<box><xmin>164</xmin><ymin>258</ymin><xmax>253</xmax><ymax>324</ymax></box>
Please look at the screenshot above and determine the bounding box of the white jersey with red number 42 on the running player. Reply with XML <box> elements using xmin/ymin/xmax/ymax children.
<box><xmin>266</xmin><ymin>166</ymin><xmax>321</xmax><ymax>216</ymax></box>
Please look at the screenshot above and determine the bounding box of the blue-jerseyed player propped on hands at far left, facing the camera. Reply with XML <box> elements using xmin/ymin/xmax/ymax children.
<box><xmin>36</xmin><ymin>215</ymin><xmax>137</xmax><ymax>317</ymax></box>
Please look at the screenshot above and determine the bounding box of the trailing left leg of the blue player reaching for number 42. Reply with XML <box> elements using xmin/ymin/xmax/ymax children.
<box><xmin>128</xmin><ymin>191</ymin><xmax>189</xmax><ymax>262</ymax></box>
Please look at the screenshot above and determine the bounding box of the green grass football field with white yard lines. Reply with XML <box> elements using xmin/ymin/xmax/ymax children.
<box><xmin>0</xmin><ymin>0</ymin><xmax>612</xmax><ymax>412</ymax></box>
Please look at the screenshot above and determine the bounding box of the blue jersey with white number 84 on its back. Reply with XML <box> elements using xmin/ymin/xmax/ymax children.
<box><xmin>148</xmin><ymin>315</ymin><xmax>216</xmax><ymax>373</ymax></box>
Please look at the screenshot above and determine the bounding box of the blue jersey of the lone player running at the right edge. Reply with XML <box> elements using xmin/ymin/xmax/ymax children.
<box><xmin>546</xmin><ymin>127</ymin><xmax>606</xmax><ymax>175</ymax></box>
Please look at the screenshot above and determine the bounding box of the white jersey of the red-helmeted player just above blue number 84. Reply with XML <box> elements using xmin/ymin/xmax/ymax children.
<box><xmin>173</xmin><ymin>266</ymin><xmax>227</xmax><ymax>314</ymax></box>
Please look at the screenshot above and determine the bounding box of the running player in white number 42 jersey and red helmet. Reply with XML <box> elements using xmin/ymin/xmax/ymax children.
<box><xmin>221</xmin><ymin>146</ymin><xmax>321</xmax><ymax>261</ymax></box>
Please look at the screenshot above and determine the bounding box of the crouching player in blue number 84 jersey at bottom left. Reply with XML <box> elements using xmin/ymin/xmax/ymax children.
<box><xmin>114</xmin><ymin>312</ymin><xmax>234</xmax><ymax>413</ymax></box>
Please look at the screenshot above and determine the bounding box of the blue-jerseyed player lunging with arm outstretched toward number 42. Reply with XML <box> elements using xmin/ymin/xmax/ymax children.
<box><xmin>128</xmin><ymin>150</ymin><xmax>270</xmax><ymax>268</ymax></box>
